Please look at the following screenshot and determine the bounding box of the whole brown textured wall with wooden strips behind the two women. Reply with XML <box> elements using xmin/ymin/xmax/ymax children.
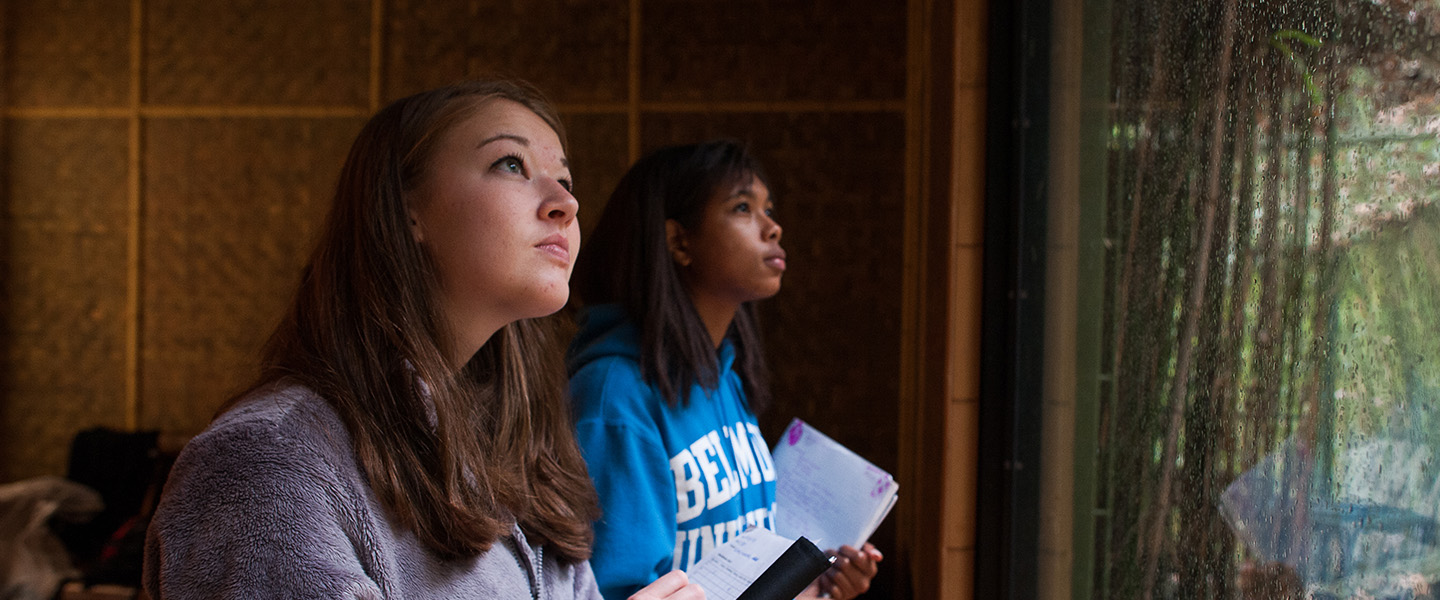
<box><xmin>0</xmin><ymin>0</ymin><xmax>907</xmax><ymax>597</ymax></box>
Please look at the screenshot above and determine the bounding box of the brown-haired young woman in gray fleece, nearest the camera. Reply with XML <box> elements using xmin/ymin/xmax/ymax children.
<box><xmin>144</xmin><ymin>82</ymin><xmax>703</xmax><ymax>600</ymax></box>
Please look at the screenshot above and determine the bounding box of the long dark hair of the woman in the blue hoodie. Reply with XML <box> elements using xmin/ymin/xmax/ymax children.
<box><xmin>572</xmin><ymin>140</ymin><xmax>770</xmax><ymax>414</ymax></box>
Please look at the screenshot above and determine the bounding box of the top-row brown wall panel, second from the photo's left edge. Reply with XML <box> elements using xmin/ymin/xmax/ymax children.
<box><xmin>144</xmin><ymin>0</ymin><xmax>370</xmax><ymax>106</ymax></box>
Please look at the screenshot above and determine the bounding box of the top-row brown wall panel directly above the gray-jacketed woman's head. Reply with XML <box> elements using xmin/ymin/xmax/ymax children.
<box><xmin>384</xmin><ymin>0</ymin><xmax>629</xmax><ymax>102</ymax></box>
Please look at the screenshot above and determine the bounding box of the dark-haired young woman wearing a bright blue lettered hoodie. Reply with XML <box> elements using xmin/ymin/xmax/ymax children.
<box><xmin>567</xmin><ymin>140</ymin><xmax>881</xmax><ymax>600</ymax></box>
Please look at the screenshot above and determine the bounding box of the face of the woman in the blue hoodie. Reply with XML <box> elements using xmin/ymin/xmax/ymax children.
<box><xmin>677</xmin><ymin>178</ymin><xmax>785</xmax><ymax>306</ymax></box>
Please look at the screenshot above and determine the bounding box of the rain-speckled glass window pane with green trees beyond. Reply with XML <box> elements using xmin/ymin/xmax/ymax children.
<box><xmin>1086</xmin><ymin>0</ymin><xmax>1440</xmax><ymax>599</ymax></box>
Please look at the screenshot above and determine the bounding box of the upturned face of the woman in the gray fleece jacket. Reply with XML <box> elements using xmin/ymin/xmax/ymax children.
<box><xmin>406</xmin><ymin>99</ymin><xmax>580</xmax><ymax>360</ymax></box>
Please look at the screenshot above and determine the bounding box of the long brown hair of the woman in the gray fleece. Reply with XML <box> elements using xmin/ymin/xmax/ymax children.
<box><xmin>241</xmin><ymin>81</ymin><xmax>599</xmax><ymax>561</ymax></box>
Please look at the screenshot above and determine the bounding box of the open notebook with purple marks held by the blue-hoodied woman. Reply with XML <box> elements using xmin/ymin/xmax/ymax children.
<box><xmin>770</xmin><ymin>419</ymin><xmax>900</xmax><ymax>548</ymax></box>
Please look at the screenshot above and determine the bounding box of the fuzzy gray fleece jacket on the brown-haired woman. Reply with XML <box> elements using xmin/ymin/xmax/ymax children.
<box><xmin>144</xmin><ymin>384</ymin><xmax>600</xmax><ymax>600</ymax></box>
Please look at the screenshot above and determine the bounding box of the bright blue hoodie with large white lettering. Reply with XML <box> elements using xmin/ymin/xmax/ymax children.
<box><xmin>567</xmin><ymin>305</ymin><xmax>775</xmax><ymax>600</ymax></box>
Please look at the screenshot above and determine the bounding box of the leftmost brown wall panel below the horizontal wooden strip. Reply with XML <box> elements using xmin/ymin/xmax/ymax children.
<box><xmin>0</xmin><ymin>121</ymin><xmax>130</xmax><ymax>481</ymax></box>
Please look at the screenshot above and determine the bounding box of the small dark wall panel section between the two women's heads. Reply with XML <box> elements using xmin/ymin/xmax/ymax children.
<box><xmin>562</xmin><ymin>115</ymin><xmax>629</xmax><ymax>235</ymax></box>
